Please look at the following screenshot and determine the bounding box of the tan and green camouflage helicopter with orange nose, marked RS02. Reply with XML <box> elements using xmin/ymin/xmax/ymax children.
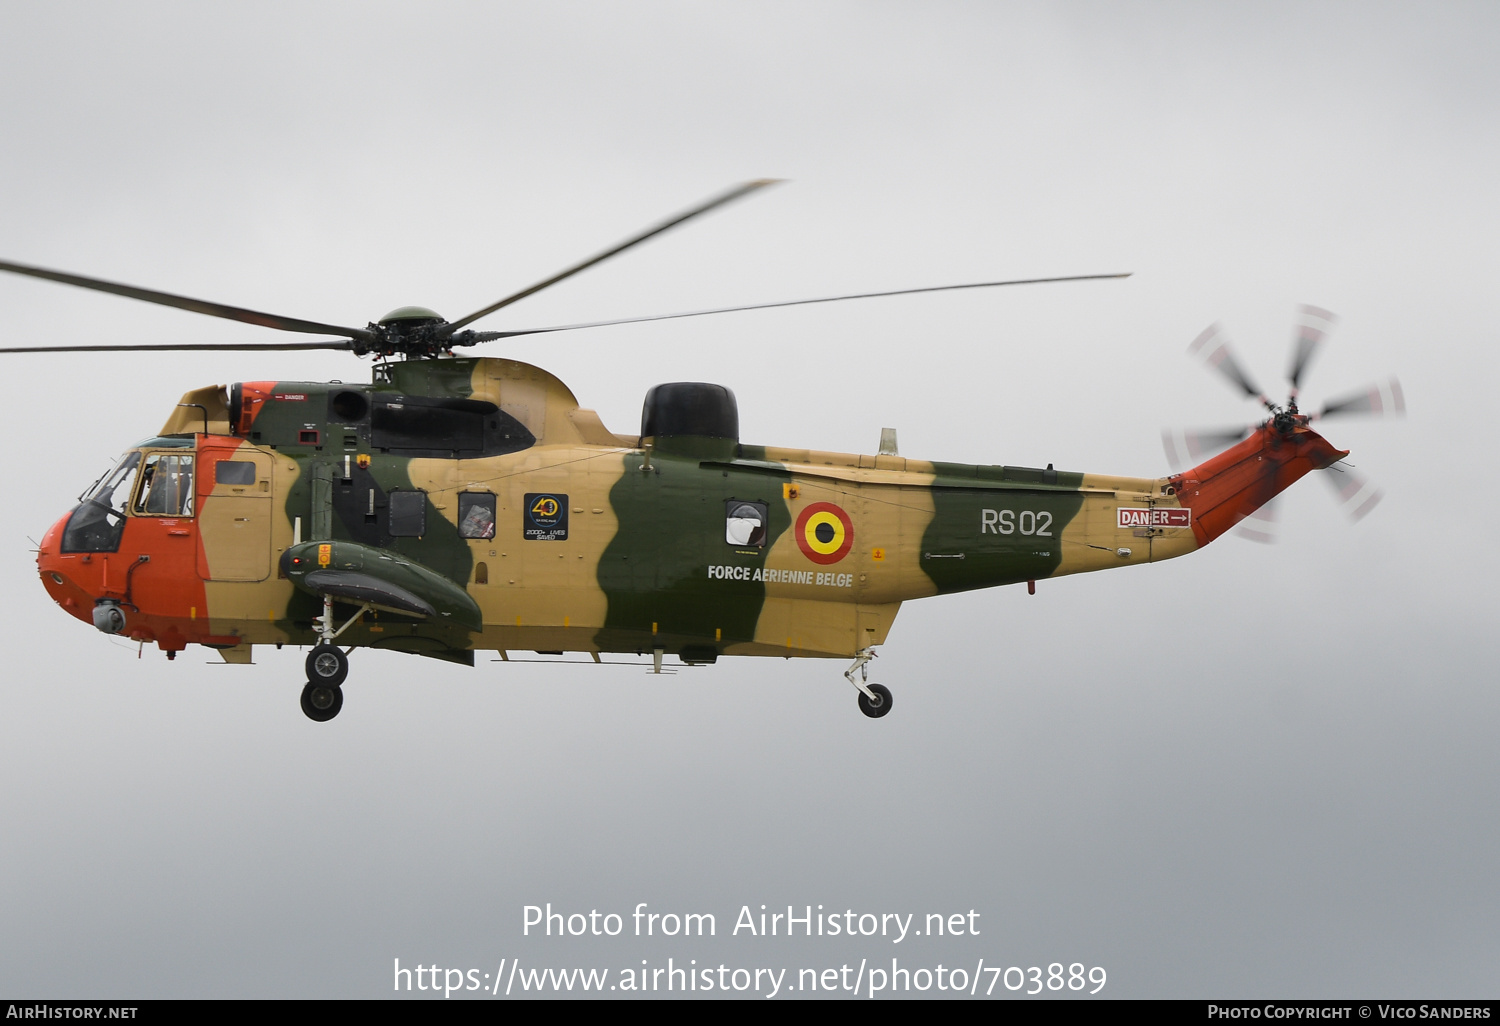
<box><xmin>0</xmin><ymin>180</ymin><xmax>1401</xmax><ymax>722</ymax></box>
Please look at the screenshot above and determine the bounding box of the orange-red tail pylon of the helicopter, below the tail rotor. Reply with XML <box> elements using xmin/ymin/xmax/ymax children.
<box><xmin>1169</xmin><ymin>422</ymin><xmax>1349</xmax><ymax>548</ymax></box>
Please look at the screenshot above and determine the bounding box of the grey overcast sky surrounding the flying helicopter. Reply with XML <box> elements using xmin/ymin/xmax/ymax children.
<box><xmin>0</xmin><ymin>3</ymin><xmax>1500</xmax><ymax>998</ymax></box>
